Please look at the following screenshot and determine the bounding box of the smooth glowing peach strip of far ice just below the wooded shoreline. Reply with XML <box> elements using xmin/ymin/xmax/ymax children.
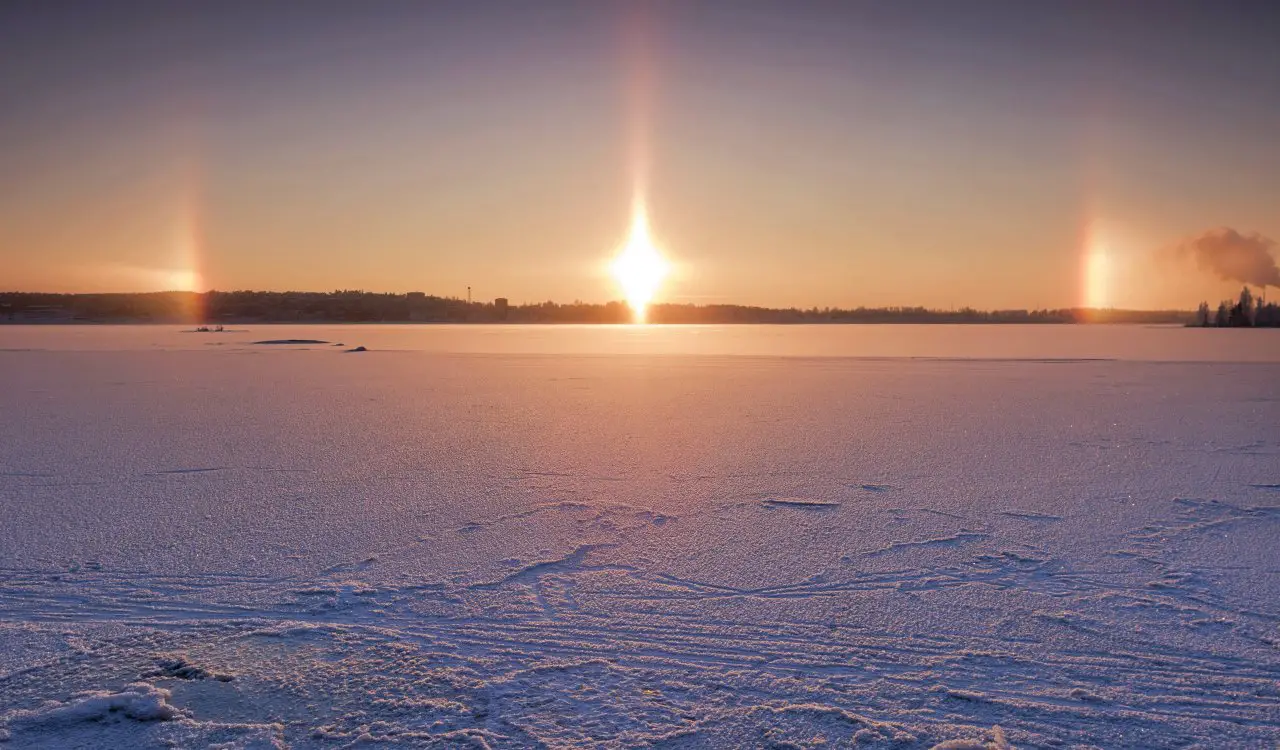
<box><xmin>0</xmin><ymin>324</ymin><xmax>1280</xmax><ymax>362</ymax></box>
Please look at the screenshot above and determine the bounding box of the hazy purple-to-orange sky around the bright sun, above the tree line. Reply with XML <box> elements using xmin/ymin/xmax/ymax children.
<box><xmin>0</xmin><ymin>0</ymin><xmax>1280</xmax><ymax>308</ymax></box>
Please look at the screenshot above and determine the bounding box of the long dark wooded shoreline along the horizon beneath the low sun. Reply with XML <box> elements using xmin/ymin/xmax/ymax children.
<box><xmin>0</xmin><ymin>289</ymin><xmax>1192</xmax><ymax>324</ymax></box>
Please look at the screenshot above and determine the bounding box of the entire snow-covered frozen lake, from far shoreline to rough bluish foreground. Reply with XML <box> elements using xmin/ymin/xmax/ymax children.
<box><xmin>0</xmin><ymin>325</ymin><xmax>1280</xmax><ymax>749</ymax></box>
